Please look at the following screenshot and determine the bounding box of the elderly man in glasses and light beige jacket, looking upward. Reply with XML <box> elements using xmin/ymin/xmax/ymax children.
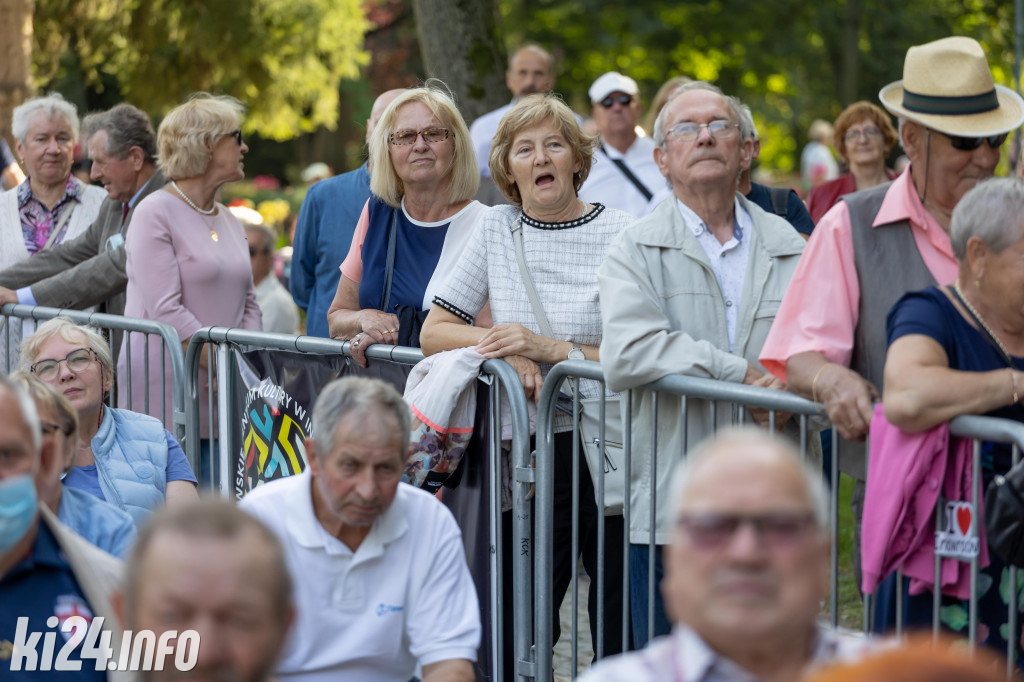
<box><xmin>598</xmin><ymin>82</ymin><xmax>805</xmax><ymax>646</ymax></box>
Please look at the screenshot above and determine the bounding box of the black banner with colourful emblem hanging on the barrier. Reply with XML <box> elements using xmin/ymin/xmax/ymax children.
<box><xmin>231</xmin><ymin>348</ymin><xmax>412</xmax><ymax>500</ymax></box>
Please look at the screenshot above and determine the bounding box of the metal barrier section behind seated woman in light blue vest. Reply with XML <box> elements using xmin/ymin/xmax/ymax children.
<box><xmin>0</xmin><ymin>303</ymin><xmax>185</xmax><ymax>443</ymax></box>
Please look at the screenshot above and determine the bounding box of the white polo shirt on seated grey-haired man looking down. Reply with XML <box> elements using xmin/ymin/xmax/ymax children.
<box><xmin>240</xmin><ymin>470</ymin><xmax>480</xmax><ymax>682</ymax></box>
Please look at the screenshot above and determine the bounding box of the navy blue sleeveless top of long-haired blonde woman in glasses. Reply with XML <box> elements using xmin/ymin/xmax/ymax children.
<box><xmin>359</xmin><ymin>195</ymin><xmax>451</xmax><ymax>312</ymax></box>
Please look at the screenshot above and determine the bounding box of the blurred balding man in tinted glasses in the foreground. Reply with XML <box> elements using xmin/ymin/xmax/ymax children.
<box><xmin>581</xmin><ymin>427</ymin><xmax>864</xmax><ymax>682</ymax></box>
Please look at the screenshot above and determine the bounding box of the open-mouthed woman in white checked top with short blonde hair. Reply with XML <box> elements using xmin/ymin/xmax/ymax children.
<box><xmin>422</xmin><ymin>94</ymin><xmax>635</xmax><ymax>655</ymax></box>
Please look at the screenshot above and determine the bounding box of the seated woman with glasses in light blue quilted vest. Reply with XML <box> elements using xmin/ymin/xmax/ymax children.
<box><xmin>22</xmin><ymin>317</ymin><xmax>198</xmax><ymax>525</ymax></box>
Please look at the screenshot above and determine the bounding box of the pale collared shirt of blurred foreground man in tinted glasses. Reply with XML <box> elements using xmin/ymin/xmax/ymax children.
<box><xmin>580</xmin><ymin>625</ymin><xmax>876</xmax><ymax>682</ymax></box>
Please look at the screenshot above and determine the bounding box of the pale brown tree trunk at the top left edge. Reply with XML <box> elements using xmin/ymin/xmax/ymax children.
<box><xmin>0</xmin><ymin>0</ymin><xmax>34</xmax><ymax>150</ymax></box>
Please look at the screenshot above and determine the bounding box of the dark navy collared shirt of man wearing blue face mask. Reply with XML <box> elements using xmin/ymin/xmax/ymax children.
<box><xmin>0</xmin><ymin>520</ymin><xmax>106</xmax><ymax>680</ymax></box>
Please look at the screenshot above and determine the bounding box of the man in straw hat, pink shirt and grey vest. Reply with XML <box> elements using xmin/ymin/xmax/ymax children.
<box><xmin>760</xmin><ymin>37</ymin><xmax>1024</xmax><ymax>584</ymax></box>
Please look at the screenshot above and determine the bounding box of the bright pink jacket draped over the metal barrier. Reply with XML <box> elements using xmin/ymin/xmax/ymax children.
<box><xmin>860</xmin><ymin>402</ymin><xmax>988</xmax><ymax>599</ymax></box>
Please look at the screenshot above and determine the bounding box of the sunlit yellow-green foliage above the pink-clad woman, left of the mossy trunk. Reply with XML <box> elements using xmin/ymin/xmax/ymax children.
<box><xmin>34</xmin><ymin>0</ymin><xmax>369</xmax><ymax>139</ymax></box>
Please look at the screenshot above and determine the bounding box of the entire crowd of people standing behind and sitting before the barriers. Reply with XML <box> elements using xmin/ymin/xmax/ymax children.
<box><xmin>0</xmin><ymin>31</ymin><xmax>1024</xmax><ymax>682</ymax></box>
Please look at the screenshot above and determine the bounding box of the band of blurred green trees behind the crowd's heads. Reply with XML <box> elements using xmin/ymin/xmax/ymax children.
<box><xmin>0</xmin><ymin>0</ymin><xmax>1014</xmax><ymax>181</ymax></box>
